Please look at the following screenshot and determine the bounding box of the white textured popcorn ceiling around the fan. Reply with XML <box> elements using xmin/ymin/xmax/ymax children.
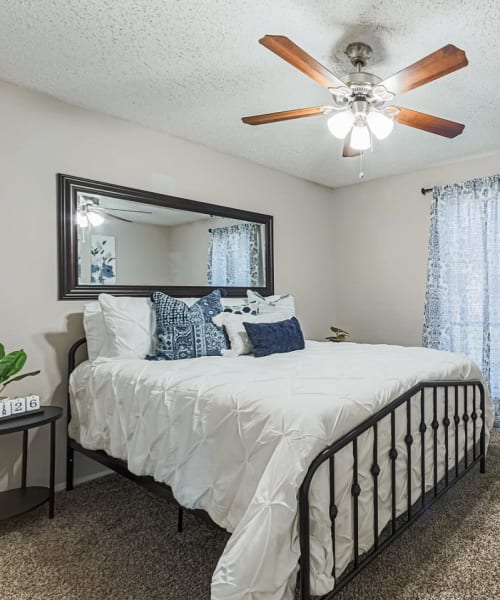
<box><xmin>0</xmin><ymin>0</ymin><xmax>500</xmax><ymax>187</ymax></box>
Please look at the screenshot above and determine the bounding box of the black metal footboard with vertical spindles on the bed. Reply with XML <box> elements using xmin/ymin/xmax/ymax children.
<box><xmin>299</xmin><ymin>380</ymin><xmax>486</xmax><ymax>600</ymax></box>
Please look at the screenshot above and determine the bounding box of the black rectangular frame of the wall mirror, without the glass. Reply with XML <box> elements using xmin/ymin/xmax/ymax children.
<box><xmin>57</xmin><ymin>173</ymin><xmax>274</xmax><ymax>300</ymax></box>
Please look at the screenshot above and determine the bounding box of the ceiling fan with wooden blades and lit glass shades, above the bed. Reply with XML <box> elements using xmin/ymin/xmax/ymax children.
<box><xmin>242</xmin><ymin>35</ymin><xmax>468</xmax><ymax>157</ymax></box>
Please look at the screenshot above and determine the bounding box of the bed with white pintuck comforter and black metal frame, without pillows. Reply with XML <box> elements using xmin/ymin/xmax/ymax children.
<box><xmin>68</xmin><ymin>340</ymin><xmax>493</xmax><ymax>600</ymax></box>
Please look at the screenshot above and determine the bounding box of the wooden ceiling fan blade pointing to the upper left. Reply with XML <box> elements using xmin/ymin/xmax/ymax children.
<box><xmin>259</xmin><ymin>35</ymin><xmax>345</xmax><ymax>88</ymax></box>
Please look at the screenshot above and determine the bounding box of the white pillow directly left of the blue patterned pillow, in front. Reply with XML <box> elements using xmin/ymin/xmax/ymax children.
<box><xmin>99</xmin><ymin>294</ymin><xmax>155</xmax><ymax>358</ymax></box>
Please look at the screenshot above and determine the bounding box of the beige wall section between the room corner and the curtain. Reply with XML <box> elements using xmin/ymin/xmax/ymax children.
<box><xmin>332</xmin><ymin>154</ymin><xmax>500</xmax><ymax>345</ymax></box>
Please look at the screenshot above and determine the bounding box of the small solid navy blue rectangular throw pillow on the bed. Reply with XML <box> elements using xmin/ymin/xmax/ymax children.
<box><xmin>243</xmin><ymin>317</ymin><xmax>305</xmax><ymax>357</ymax></box>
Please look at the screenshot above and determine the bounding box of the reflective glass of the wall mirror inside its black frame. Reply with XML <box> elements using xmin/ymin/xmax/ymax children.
<box><xmin>76</xmin><ymin>192</ymin><xmax>266</xmax><ymax>287</ymax></box>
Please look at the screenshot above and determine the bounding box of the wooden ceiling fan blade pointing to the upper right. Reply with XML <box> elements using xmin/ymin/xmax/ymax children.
<box><xmin>379</xmin><ymin>44</ymin><xmax>469</xmax><ymax>95</ymax></box>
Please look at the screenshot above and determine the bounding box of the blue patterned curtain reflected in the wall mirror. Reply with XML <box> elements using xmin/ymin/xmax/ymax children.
<box><xmin>207</xmin><ymin>223</ymin><xmax>264</xmax><ymax>287</ymax></box>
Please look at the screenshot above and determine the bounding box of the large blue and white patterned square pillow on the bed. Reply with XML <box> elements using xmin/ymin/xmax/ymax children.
<box><xmin>147</xmin><ymin>290</ymin><xmax>228</xmax><ymax>360</ymax></box>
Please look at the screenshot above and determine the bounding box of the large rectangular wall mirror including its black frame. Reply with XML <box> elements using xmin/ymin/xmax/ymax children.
<box><xmin>58</xmin><ymin>175</ymin><xmax>274</xmax><ymax>300</ymax></box>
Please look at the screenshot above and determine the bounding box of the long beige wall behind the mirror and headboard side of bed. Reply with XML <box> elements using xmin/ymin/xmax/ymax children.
<box><xmin>0</xmin><ymin>83</ymin><xmax>334</xmax><ymax>489</ymax></box>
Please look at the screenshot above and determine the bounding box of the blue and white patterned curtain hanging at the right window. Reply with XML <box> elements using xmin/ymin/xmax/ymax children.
<box><xmin>423</xmin><ymin>175</ymin><xmax>500</xmax><ymax>427</ymax></box>
